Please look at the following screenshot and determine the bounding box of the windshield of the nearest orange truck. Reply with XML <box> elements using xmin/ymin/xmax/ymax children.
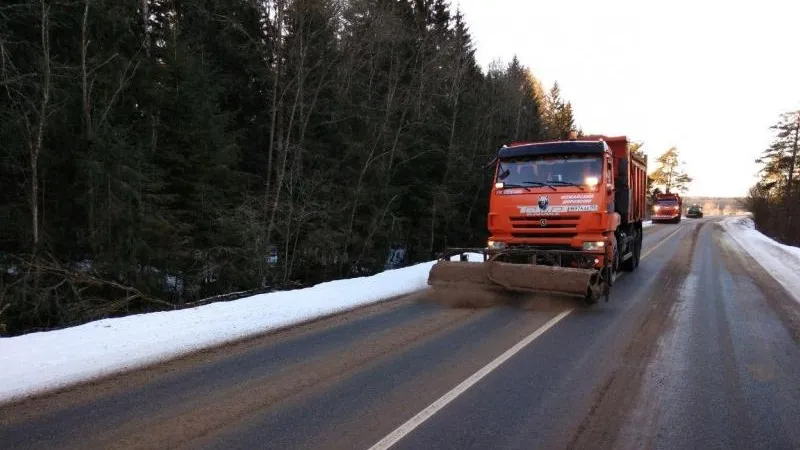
<box><xmin>496</xmin><ymin>155</ymin><xmax>603</xmax><ymax>186</ymax></box>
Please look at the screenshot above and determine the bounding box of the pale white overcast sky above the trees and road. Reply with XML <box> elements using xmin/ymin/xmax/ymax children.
<box><xmin>452</xmin><ymin>0</ymin><xmax>800</xmax><ymax>197</ymax></box>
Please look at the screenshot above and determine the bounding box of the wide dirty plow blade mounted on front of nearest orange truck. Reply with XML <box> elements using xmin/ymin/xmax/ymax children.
<box><xmin>428</xmin><ymin>260</ymin><xmax>600</xmax><ymax>298</ymax></box>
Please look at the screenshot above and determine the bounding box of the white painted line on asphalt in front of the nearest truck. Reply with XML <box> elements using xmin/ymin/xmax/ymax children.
<box><xmin>369</xmin><ymin>309</ymin><xmax>574</xmax><ymax>450</ymax></box>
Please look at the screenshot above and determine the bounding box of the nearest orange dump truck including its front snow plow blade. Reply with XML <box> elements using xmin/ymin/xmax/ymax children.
<box><xmin>428</xmin><ymin>135</ymin><xmax>647</xmax><ymax>303</ymax></box>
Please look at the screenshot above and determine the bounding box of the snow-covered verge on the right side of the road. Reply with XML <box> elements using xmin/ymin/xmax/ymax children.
<box><xmin>722</xmin><ymin>216</ymin><xmax>800</xmax><ymax>302</ymax></box>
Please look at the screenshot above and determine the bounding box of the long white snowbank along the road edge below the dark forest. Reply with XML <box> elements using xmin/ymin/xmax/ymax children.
<box><xmin>0</xmin><ymin>253</ymin><xmax>483</xmax><ymax>403</ymax></box>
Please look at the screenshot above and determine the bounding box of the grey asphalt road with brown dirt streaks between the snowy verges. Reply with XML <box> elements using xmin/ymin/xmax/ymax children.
<box><xmin>0</xmin><ymin>218</ymin><xmax>800</xmax><ymax>449</ymax></box>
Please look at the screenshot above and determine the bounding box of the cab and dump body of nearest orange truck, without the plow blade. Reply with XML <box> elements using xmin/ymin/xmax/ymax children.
<box><xmin>487</xmin><ymin>136</ymin><xmax>646</xmax><ymax>270</ymax></box>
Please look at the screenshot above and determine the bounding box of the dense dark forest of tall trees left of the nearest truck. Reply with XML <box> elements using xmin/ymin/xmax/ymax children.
<box><xmin>0</xmin><ymin>0</ymin><xmax>574</xmax><ymax>335</ymax></box>
